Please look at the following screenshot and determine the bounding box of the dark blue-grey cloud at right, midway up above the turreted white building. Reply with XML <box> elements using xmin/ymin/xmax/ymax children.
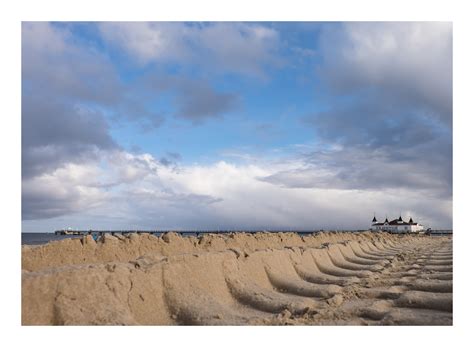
<box><xmin>305</xmin><ymin>97</ymin><xmax>450</xmax><ymax>149</ymax></box>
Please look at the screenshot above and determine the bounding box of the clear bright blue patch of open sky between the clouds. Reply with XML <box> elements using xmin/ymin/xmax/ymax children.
<box><xmin>95</xmin><ymin>23</ymin><xmax>325</xmax><ymax>164</ymax></box>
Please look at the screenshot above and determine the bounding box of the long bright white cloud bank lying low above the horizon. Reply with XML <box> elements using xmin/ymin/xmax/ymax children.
<box><xmin>24</xmin><ymin>152</ymin><xmax>451</xmax><ymax>230</ymax></box>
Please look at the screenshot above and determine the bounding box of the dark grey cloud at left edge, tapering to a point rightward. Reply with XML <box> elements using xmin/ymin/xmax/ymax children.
<box><xmin>22</xmin><ymin>95</ymin><xmax>118</xmax><ymax>178</ymax></box>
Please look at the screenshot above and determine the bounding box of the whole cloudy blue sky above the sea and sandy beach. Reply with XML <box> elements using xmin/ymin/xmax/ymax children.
<box><xmin>21</xmin><ymin>22</ymin><xmax>453</xmax><ymax>232</ymax></box>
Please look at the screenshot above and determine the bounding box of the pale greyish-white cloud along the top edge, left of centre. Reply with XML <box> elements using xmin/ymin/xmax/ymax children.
<box><xmin>99</xmin><ymin>22</ymin><xmax>279</xmax><ymax>76</ymax></box>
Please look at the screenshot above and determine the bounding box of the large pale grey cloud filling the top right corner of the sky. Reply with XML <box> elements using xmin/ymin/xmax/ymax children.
<box><xmin>317</xmin><ymin>22</ymin><xmax>453</xmax><ymax>124</ymax></box>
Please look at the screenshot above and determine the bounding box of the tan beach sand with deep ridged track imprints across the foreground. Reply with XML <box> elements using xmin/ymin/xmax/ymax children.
<box><xmin>22</xmin><ymin>232</ymin><xmax>453</xmax><ymax>325</ymax></box>
